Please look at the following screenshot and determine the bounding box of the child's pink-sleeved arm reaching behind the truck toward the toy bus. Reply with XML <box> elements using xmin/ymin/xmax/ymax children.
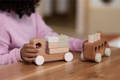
<box><xmin>36</xmin><ymin>14</ymin><xmax>83</xmax><ymax>51</ymax></box>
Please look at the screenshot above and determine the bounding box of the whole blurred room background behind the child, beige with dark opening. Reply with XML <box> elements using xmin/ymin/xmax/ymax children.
<box><xmin>37</xmin><ymin>0</ymin><xmax>120</xmax><ymax>37</ymax></box>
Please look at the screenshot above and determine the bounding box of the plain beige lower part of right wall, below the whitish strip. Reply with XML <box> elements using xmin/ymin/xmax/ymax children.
<box><xmin>88</xmin><ymin>8</ymin><xmax>120</xmax><ymax>34</ymax></box>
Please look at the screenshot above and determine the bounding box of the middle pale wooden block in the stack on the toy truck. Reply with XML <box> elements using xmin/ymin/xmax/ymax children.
<box><xmin>48</xmin><ymin>42</ymin><xmax>69</xmax><ymax>48</ymax></box>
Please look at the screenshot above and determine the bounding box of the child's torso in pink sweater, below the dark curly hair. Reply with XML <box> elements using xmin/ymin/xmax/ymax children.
<box><xmin>0</xmin><ymin>12</ymin><xmax>36</xmax><ymax>50</ymax></box>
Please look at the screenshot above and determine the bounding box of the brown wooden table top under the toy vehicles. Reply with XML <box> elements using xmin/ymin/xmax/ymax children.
<box><xmin>0</xmin><ymin>49</ymin><xmax>120</xmax><ymax>80</ymax></box>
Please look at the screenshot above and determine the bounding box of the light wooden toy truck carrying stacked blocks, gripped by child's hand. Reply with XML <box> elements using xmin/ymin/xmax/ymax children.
<box><xmin>30</xmin><ymin>35</ymin><xmax>73</xmax><ymax>65</ymax></box>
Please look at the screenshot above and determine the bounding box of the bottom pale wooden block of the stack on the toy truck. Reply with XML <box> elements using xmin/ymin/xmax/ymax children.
<box><xmin>49</xmin><ymin>48</ymin><xmax>69</xmax><ymax>54</ymax></box>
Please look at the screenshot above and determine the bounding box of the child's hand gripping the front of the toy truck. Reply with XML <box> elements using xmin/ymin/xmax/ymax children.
<box><xmin>20</xmin><ymin>44</ymin><xmax>38</xmax><ymax>62</ymax></box>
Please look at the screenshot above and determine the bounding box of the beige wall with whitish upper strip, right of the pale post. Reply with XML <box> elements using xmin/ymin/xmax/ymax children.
<box><xmin>88</xmin><ymin>0</ymin><xmax>120</xmax><ymax>34</ymax></box>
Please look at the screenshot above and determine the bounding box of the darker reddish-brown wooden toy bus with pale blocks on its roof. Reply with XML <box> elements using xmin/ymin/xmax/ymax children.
<box><xmin>81</xmin><ymin>33</ymin><xmax>111</xmax><ymax>63</ymax></box>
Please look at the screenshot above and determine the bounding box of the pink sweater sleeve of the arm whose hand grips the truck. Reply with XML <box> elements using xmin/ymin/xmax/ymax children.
<box><xmin>0</xmin><ymin>25</ymin><xmax>21</xmax><ymax>65</ymax></box>
